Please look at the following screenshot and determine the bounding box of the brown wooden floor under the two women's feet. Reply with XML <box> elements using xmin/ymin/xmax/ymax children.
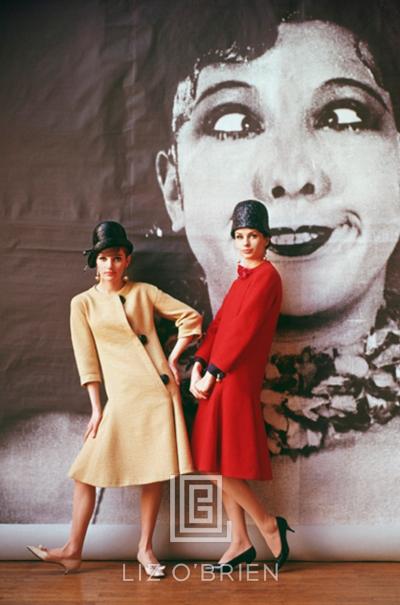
<box><xmin>0</xmin><ymin>561</ymin><xmax>400</xmax><ymax>605</ymax></box>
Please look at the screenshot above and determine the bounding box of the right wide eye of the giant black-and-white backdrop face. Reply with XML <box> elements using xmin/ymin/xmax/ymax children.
<box><xmin>315</xmin><ymin>99</ymin><xmax>380</xmax><ymax>132</ymax></box>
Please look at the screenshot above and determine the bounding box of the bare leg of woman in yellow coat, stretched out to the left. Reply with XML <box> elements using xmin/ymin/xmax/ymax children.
<box><xmin>41</xmin><ymin>480</ymin><xmax>96</xmax><ymax>559</ymax></box>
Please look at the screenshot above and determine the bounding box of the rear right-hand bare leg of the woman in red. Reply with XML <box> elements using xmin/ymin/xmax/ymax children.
<box><xmin>222</xmin><ymin>477</ymin><xmax>282</xmax><ymax>557</ymax></box>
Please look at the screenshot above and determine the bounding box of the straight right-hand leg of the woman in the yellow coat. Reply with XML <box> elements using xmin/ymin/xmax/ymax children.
<box><xmin>138</xmin><ymin>482</ymin><xmax>163</xmax><ymax>565</ymax></box>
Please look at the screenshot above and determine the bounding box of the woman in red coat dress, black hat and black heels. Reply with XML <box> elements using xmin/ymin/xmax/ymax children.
<box><xmin>191</xmin><ymin>200</ymin><xmax>293</xmax><ymax>571</ymax></box>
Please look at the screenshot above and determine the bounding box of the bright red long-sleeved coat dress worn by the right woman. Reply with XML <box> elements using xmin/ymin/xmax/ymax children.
<box><xmin>191</xmin><ymin>261</ymin><xmax>282</xmax><ymax>479</ymax></box>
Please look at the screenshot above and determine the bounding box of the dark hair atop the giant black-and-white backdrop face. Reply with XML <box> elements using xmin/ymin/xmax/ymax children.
<box><xmin>138</xmin><ymin>0</ymin><xmax>400</xmax><ymax>130</ymax></box>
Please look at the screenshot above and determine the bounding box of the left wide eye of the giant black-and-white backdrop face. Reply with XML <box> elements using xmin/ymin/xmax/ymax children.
<box><xmin>202</xmin><ymin>103</ymin><xmax>263</xmax><ymax>140</ymax></box>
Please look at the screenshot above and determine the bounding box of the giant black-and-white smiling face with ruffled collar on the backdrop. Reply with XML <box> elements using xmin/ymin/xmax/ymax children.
<box><xmin>157</xmin><ymin>3</ymin><xmax>400</xmax><ymax>454</ymax></box>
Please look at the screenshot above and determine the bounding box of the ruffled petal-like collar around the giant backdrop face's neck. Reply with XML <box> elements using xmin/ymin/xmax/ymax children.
<box><xmin>261</xmin><ymin>293</ymin><xmax>400</xmax><ymax>458</ymax></box>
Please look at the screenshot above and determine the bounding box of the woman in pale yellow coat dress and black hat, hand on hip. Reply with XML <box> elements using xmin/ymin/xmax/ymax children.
<box><xmin>28</xmin><ymin>221</ymin><xmax>201</xmax><ymax>577</ymax></box>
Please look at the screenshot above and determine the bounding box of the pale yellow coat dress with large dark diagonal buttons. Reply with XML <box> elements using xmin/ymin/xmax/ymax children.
<box><xmin>68</xmin><ymin>282</ymin><xmax>202</xmax><ymax>487</ymax></box>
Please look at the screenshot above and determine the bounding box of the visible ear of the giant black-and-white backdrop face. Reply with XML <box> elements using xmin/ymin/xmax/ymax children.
<box><xmin>156</xmin><ymin>151</ymin><xmax>185</xmax><ymax>231</ymax></box>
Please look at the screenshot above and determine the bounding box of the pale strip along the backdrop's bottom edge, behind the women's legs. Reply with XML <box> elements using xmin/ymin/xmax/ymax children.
<box><xmin>0</xmin><ymin>522</ymin><xmax>400</xmax><ymax>561</ymax></box>
